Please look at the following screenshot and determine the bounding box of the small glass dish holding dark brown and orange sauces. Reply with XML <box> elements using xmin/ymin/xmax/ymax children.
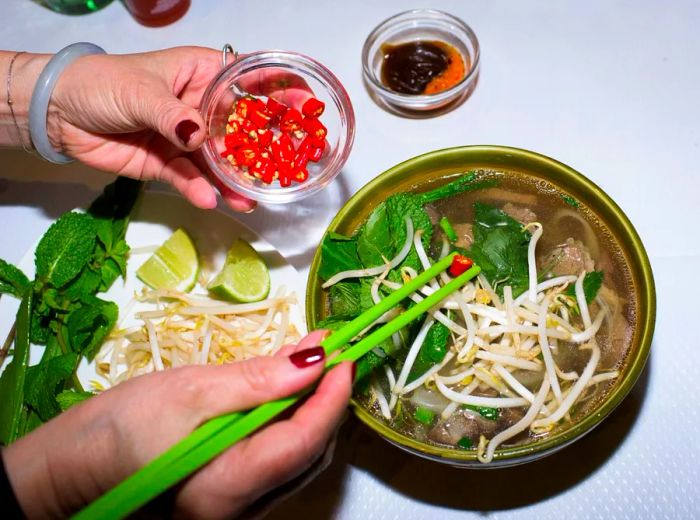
<box><xmin>362</xmin><ymin>9</ymin><xmax>479</xmax><ymax>116</ymax></box>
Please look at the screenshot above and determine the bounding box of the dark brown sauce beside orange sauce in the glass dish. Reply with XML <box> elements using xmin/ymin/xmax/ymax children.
<box><xmin>381</xmin><ymin>41</ymin><xmax>450</xmax><ymax>95</ymax></box>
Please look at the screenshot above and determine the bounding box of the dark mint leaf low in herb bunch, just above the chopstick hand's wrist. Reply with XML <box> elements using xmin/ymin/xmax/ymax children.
<box><xmin>24</xmin><ymin>352</ymin><xmax>78</xmax><ymax>421</ymax></box>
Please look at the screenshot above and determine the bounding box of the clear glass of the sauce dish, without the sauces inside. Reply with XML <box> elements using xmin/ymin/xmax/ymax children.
<box><xmin>362</xmin><ymin>9</ymin><xmax>479</xmax><ymax>115</ymax></box>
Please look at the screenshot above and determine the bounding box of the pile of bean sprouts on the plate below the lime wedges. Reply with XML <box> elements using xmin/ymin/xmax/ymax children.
<box><xmin>94</xmin><ymin>287</ymin><xmax>300</xmax><ymax>389</ymax></box>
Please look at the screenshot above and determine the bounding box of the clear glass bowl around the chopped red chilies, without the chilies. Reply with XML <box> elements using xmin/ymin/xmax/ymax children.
<box><xmin>201</xmin><ymin>51</ymin><xmax>355</xmax><ymax>204</ymax></box>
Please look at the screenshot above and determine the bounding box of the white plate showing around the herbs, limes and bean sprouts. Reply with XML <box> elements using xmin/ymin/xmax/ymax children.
<box><xmin>0</xmin><ymin>191</ymin><xmax>306</xmax><ymax>389</ymax></box>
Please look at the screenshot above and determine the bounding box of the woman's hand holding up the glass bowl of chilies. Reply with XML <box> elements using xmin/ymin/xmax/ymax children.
<box><xmin>48</xmin><ymin>47</ymin><xmax>255</xmax><ymax>211</ymax></box>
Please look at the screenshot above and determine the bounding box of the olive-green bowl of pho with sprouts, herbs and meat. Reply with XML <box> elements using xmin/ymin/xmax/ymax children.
<box><xmin>306</xmin><ymin>146</ymin><xmax>656</xmax><ymax>468</ymax></box>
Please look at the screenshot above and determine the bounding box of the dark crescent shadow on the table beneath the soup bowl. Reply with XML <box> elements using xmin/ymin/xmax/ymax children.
<box><xmin>268</xmin><ymin>349</ymin><xmax>653</xmax><ymax>520</ymax></box>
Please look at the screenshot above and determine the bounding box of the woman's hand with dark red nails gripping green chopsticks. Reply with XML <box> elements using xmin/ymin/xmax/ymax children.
<box><xmin>3</xmin><ymin>331</ymin><xmax>352</xmax><ymax>518</ymax></box>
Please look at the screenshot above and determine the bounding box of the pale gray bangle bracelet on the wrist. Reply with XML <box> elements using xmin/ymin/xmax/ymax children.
<box><xmin>29</xmin><ymin>42</ymin><xmax>105</xmax><ymax>164</ymax></box>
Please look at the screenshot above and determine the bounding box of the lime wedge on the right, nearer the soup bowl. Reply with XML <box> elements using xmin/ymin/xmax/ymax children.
<box><xmin>207</xmin><ymin>239</ymin><xmax>270</xmax><ymax>303</ymax></box>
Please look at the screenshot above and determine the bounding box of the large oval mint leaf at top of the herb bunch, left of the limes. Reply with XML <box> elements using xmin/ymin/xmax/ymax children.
<box><xmin>34</xmin><ymin>212</ymin><xmax>97</xmax><ymax>288</ymax></box>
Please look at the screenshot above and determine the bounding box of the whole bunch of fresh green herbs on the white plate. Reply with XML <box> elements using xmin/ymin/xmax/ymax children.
<box><xmin>0</xmin><ymin>178</ymin><xmax>141</xmax><ymax>444</ymax></box>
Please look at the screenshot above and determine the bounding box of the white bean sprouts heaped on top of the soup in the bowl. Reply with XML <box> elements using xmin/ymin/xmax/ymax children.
<box><xmin>324</xmin><ymin>217</ymin><xmax>618</xmax><ymax>463</ymax></box>
